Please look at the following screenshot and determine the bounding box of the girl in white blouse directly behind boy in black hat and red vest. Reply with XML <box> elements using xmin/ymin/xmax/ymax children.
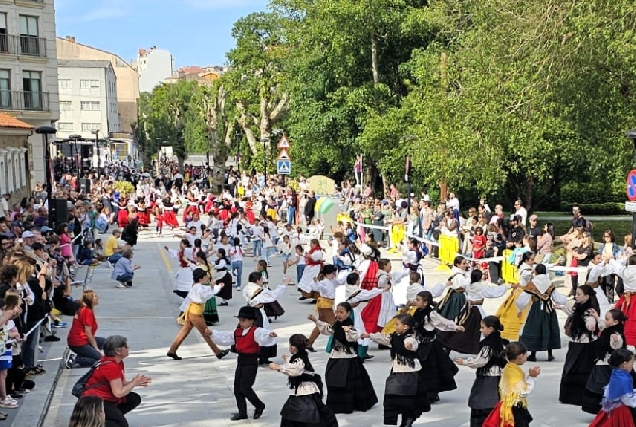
<box><xmin>243</xmin><ymin>271</ymin><xmax>286</xmax><ymax>365</ymax></box>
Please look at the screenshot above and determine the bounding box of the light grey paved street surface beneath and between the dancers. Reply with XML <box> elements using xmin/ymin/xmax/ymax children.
<box><xmin>33</xmin><ymin>234</ymin><xmax>592</xmax><ymax>427</ymax></box>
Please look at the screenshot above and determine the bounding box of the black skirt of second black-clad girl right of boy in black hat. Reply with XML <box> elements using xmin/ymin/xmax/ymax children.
<box><xmin>325</xmin><ymin>357</ymin><xmax>378</xmax><ymax>414</ymax></box>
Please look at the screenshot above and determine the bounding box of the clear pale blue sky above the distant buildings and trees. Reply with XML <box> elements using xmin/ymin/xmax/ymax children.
<box><xmin>55</xmin><ymin>0</ymin><xmax>267</xmax><ymax>69</ymax></box>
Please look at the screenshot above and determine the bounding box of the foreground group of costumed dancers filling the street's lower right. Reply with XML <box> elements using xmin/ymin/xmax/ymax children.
<box><xmin>161</xmin><ymin>209</ymin><xmax>636</xmax><ymax>427</ymax></box>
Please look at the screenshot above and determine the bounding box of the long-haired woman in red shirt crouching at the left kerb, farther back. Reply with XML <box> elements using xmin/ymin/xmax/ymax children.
<box><xmin>66</xmin><ymin>291</ymin><xmax>104</xmax><ymax>369</ymax></box>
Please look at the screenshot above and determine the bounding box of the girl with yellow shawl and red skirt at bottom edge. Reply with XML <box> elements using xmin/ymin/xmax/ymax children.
<box><xmin>483</xmin><ymin>342</ymin><xmax>541</xmax><ymax>427</ymax></box>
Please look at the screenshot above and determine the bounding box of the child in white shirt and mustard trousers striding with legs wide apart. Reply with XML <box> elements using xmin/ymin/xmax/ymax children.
<box><xmin>167</xmin><ymin>268</ymin><xmax>229</xmax><ymax>360</ymax></box>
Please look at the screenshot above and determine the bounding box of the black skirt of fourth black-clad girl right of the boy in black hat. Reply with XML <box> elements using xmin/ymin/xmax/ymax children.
<box><xmin>417</xmin><ymin>340</ymin><xmax>459</xmax><ymax>398</ymax></box>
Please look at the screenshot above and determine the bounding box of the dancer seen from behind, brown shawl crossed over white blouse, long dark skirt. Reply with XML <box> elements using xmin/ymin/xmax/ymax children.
<box><xmin>516</xmin><ymin>264</ymin><xmax>567</xmax><ymax>362</ymax></box>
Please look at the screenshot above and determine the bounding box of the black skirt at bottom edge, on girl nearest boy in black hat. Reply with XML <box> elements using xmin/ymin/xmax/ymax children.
<box><xmin>280</xmin><ymin>393</ymin><xmax>338</xmax><ymax>427</ymax></box>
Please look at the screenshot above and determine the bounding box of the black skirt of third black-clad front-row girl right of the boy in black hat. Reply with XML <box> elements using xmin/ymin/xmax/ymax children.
<box><xmin>384</xmin><ymin>371</ymin><xmax>431</xmax><ymax>425</ymax></box>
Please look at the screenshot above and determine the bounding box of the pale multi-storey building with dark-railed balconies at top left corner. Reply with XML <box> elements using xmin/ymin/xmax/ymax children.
<box><xmin>0</xmin><ymin>0</ymin><xmax>59</xmax><ymax>186</ymax></box>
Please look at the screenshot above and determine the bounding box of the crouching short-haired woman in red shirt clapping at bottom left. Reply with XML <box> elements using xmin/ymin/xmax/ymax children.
<box><xmin>82</xmin><ymin>335</ymin><xmax>152</xmax><ymax>427</ymax></box>
